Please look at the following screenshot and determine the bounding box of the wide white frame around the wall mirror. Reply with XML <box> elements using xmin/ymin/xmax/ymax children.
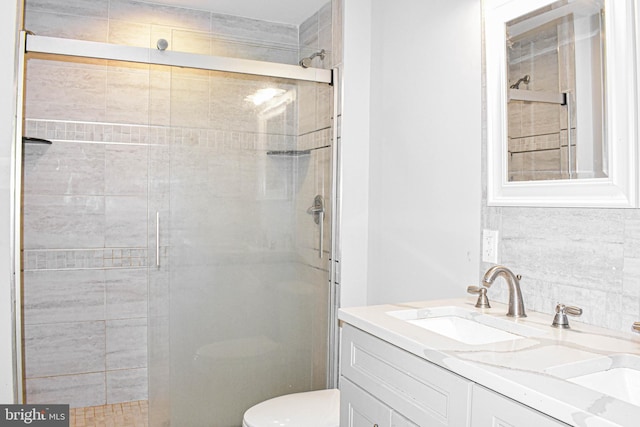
<box><xmin>484</xmin><ymin>0</ymin><xmax>638</xmax><ymax>208</ymax></box>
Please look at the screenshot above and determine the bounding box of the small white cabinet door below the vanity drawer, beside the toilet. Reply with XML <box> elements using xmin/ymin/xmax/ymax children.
<box><xmin>340</xmin><ymin>377</ymin><xmax>391</xmax><ymax>427</ymax></box>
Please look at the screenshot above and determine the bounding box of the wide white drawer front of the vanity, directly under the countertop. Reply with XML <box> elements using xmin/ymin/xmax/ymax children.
<box><xmin>340</xmin><ymin>324</ymin><xmax>472</xmax><ymax>427</ymax></box>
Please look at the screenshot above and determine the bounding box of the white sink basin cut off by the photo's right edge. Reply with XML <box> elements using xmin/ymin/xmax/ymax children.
<box><xmin>567</xmin><ymin>368</ymin><xmax>640</xmax><ymax>406</ymax></box>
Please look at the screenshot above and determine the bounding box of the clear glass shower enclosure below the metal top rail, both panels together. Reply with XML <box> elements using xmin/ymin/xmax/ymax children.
<box><xmin>22</xmin><ymin>30</ymin><xmax>335</xmax><ymax>427</ymax></box>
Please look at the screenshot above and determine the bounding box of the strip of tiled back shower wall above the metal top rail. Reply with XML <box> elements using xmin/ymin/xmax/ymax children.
<box><xmin>25</xmin><ymin>0</ymin><xmax>298</xmax><ymax>64</ymax></box>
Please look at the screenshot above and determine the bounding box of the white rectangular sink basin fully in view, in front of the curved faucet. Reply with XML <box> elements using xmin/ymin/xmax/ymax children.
<box><xmin>387</xmin><ymin>307</ymin><xmax>543</xmax><ymax>345</ymax></box>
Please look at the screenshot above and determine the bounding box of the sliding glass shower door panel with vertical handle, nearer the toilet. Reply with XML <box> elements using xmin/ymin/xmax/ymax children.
<box><xmin>149</xmin><ymin>67</ymin><xmax>332</xmax><ymax>427</ymax></box>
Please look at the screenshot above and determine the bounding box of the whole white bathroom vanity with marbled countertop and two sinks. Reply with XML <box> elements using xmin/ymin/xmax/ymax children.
<box><xmin>339</xmin><ymin>299</ymin><xmax>640</xmax><ymax>427</ymax></box>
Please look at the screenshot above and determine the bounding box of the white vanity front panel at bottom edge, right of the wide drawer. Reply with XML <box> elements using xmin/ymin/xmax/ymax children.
<box><xmin>471</xmin><ymin>384</ymin><xmax>568</xmax><ymax>427</ymax></box>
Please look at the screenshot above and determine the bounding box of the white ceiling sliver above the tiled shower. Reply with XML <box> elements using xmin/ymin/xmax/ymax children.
<box><xmin>147</xmin><ymin>0</ymin><xmax>329</xmax><ymax>25</ymax></box>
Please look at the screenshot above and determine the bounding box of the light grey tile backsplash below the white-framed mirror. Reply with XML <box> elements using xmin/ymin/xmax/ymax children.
<box><xmin>481</xmin><ymin>207</ymin><xmax>640</xmax><ymax>331</ymax></box>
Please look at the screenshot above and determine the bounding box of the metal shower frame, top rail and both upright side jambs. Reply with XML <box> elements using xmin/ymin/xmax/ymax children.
<box><xmin>12</xmin><ymin>30</ymin><xmax>341</xmax><ymax>404</ymax></box>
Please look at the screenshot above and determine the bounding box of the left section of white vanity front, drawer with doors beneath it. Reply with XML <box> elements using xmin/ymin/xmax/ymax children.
<box><xmin>340</xmin><ymin>324</ymin><xmax>473</xmax><ymax>427</ymax></box>
